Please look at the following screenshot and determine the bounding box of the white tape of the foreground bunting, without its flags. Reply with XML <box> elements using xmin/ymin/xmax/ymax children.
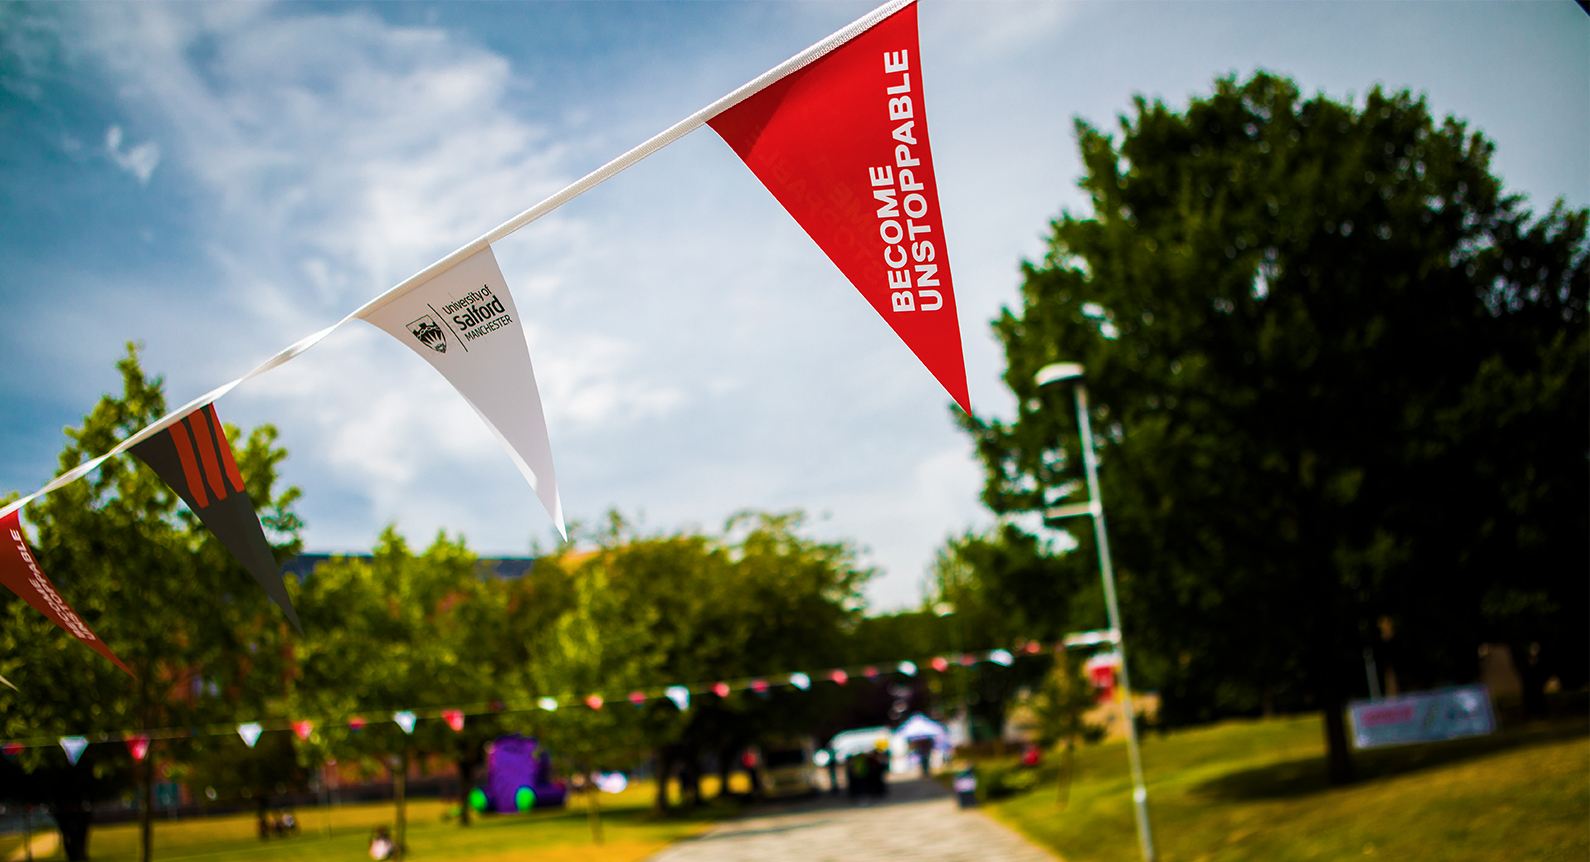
<box><xmin>0</xmin><ymin>0</ymin><xmax>916</xmax><ymax>517</ymax></box>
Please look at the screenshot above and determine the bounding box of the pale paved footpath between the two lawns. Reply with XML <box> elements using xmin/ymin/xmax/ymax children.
<box><xmin>647</xmin><ymin>779</ymin><xmax>1056</xmax><ymax>862</ymax></box>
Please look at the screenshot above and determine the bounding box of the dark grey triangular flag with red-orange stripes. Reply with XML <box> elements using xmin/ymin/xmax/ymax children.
<box><xmin>130</xmin><ymin>404</ymin><xmax>302</xmax><ymax>630</ymax></box>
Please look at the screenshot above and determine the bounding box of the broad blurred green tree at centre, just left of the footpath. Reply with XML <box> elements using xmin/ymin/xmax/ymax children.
<box><xmin>536</xmin><ymin>512</ymin><xmax>871</xmax><ymax>810</ymax></box>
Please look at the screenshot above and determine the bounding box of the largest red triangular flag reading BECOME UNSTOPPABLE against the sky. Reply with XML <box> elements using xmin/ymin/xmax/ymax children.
<box><xmin>708</xmin><ymin>3</ymin><xmax>971</xmax><ymax>412</ymax></box>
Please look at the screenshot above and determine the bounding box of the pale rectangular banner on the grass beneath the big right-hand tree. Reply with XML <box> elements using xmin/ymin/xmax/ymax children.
<box><xmin>1348</xmin><ymin>685</ymin><xmax>1496</xmax><ymax>749</ymax></box>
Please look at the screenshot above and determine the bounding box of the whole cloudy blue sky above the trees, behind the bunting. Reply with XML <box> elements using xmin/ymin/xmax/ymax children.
<box><xmin>0</xmin><ymin>0</ymin><xmax>1590</xmax><ymax>609</ymax></box>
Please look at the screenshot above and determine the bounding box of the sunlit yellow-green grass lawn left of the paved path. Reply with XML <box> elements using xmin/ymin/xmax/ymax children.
<box><xmin>0</xmin><ymin>782</ymin><xmax>736</xmax><ymax>862</ymax></box>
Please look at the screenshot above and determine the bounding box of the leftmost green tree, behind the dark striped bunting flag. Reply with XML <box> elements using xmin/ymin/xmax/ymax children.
<box><xmin>0</xmin><ymin>345</ymin><xmax>301</xmax><ymax>859</ymax></box>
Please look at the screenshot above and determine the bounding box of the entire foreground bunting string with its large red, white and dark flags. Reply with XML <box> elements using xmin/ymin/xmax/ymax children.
<box><xmin>0</xmin><ymin>0</ymin><xmax>971</xmax><ymax>687</ymax></box>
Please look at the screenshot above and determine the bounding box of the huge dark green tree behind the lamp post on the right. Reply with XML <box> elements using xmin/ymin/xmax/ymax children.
<box><xmin>967</xmin><ymin>73</ymin><xmax>1590</xmax><ymax>781</ymax></box>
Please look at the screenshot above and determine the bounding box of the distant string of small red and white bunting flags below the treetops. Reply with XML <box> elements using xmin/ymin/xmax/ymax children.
<box><xmin>0</xmin><ymin>630</ymin><xmax>1121</xmax><ymax>765</ymax></box>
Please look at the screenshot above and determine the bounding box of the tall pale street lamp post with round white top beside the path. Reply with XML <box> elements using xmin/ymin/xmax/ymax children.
<box><xmin>1035</xmin><ymin>363</ymin><xmax>1154</xmax><ymax>862</ymax></box>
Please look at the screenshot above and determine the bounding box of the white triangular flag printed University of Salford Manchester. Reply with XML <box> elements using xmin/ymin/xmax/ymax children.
<box><xmin>359</xmin><ymin>245</ymin><xmax>568</xmax><ymax>538</ymax></box>
